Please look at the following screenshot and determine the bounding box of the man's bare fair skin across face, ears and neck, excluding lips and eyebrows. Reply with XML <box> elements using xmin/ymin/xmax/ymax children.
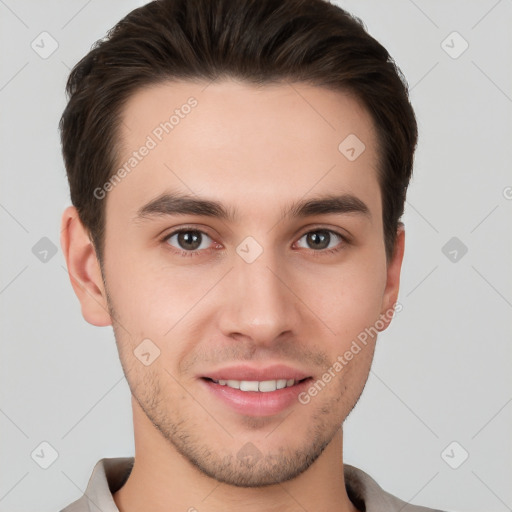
<box><xmin>61</xmin><ymin>80</ymin><xmax>404</xmax><ymax>512</ymax></box>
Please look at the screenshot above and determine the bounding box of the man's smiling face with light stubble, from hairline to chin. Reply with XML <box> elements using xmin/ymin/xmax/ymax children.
<box><xmin>82</xmin><ymin>81</ymin><xmax>401</xmax><ymax>486</ymax></box>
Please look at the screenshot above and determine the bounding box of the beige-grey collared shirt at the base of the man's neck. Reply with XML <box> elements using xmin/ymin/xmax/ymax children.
<box><xmin>60</xmin><ymin>457</ymin><xmax>448</xmax><ymax>512</ymax></box>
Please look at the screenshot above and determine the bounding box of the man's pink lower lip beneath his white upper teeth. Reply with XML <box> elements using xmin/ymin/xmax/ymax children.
<box><xmin>200</xmin><ymin>378</ymin><xmax>311</xmax><ymax>416</ymax></box>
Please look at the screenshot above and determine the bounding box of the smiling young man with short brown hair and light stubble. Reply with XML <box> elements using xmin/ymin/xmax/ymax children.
<box><xmin>61</xmin><ymin>0</ymin><xmax>446</xmax><ymax>512</ymax></box>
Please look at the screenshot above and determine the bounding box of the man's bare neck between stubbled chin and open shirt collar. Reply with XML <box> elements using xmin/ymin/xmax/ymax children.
<box><xmin>113</xmin><ymin>399</ymin><xmax>357</xmax><ymax>512</ymax></box>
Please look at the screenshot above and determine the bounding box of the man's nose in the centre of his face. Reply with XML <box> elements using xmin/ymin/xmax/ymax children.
<box><xmin>219</xmin><ymin>245</ymin><xmax>300</xmax><ymax>346</ymax></box>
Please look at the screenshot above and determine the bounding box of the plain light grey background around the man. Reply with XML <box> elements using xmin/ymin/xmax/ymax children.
<box><xmin>0</xmin><ymin>0</ymin><xmax>512</xmax><ymax>512</ymax></box>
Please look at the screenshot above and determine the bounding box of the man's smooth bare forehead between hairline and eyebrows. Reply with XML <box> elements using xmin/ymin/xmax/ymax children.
<box><xmin>107</xmin><ymin>80</ymin><xmax>380</xmax><ymax>222</ymax></box>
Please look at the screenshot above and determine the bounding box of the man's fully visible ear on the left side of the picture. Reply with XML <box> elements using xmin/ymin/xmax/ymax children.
<box><xmin>60</xmin><ymin>206</ymin><xmax>112</xmax><ymax>327</ymax></box>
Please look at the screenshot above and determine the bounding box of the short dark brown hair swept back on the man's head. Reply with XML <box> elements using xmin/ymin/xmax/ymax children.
<box><xmin>59</xmin><ymin>0</ymin><xmax>418</xmax><ymax>263</ymax></box>
